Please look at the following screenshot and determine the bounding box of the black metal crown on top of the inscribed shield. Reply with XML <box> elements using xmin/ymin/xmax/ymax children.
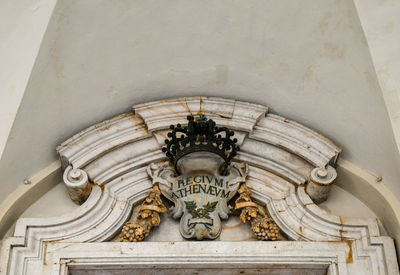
<box><xmin>162</xmin><ymin>114</ymin><xmax>240</xmax><ymax>174</ymax></box>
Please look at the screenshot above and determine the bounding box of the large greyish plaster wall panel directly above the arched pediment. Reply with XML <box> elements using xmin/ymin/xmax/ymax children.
<box><xmin>0</xmin><ymin>0</ymin><xmax>400</xmax><ymax>203</ymax></box>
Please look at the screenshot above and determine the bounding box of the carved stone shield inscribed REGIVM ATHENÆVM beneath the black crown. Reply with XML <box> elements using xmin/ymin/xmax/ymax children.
<box><xmin>149</xmin><ymin>157</ymin><xmax>247</xmax><ymax>240</ymax></box>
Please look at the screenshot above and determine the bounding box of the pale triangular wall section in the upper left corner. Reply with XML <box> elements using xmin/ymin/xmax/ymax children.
<box><xmin>0</xmin><ymin>0</ymin><xmax>56</xmax><ymax>158</ymax></box>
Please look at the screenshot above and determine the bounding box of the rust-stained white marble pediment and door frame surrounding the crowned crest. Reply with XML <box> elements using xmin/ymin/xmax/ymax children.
<box><xmin>0</xmin><ymin>97</ymin><xmax>399</xmax><ymax>275</ymax></box>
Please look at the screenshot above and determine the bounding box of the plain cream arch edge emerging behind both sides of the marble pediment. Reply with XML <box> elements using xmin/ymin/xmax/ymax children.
<box><xmin>0</xmin><ymin>158</ymin><xmax>400</xmax><ymax>246</ymax></box>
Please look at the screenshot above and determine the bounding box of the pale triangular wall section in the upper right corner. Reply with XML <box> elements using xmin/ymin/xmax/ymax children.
<box><xmin>354</xmin><ymin>0</ymin><xmax>400</xmax><ymax>153</ymax></box>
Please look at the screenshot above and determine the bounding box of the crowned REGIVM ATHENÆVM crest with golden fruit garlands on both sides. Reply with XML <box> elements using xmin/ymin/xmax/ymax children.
<box><xmin>120</xmin><ymin>114</ymin><xmax>281</xmax><ymax>241</ymax></box>
